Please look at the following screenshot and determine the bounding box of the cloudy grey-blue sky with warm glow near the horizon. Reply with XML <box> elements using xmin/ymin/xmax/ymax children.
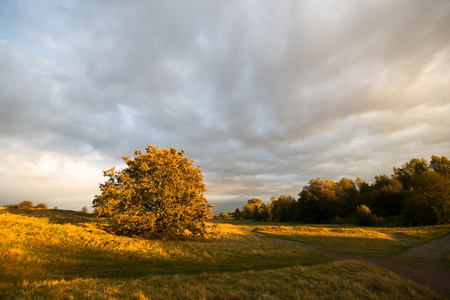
<box><xmin>0</xmin><ymin>0</ymin><xmax>450</xmax><ymax>212</ymax></box>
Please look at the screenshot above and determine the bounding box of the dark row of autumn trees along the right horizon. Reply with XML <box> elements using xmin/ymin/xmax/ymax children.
<box><xmin>237</xmin><ymin>155</ymin><xmax>450</xmax><ymax>225</ymax></box>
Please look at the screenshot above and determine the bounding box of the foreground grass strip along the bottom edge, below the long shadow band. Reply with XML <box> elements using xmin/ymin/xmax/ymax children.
<box><xmin>0</xmin><ymin>261</ymin><xmax>444</xmax><ymax>300</ymax></box>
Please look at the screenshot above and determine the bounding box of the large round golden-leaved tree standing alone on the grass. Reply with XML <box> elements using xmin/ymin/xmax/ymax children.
<box><xmin>93</xmin><ymin>145</ymin><xmax>212</xmax><ymax>239</ymax></box>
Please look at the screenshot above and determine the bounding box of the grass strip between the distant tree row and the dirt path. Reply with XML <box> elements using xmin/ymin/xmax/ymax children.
<box><xmin>253</xmin><ymin>225</ymin><xmax>450</xmax><ymax>257</ymax></box>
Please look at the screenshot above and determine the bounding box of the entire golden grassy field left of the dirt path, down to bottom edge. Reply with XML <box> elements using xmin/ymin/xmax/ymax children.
<box><xmin>0</xmin><ymin>208</ymin><xmax>448</xmax><ymax>299</ymax></box>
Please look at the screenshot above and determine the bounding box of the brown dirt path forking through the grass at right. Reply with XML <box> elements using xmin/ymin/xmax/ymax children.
<box><xmin>253</xmin><ymin>234</ymin><xmax>450</xmax><ymax>298</ymax></box>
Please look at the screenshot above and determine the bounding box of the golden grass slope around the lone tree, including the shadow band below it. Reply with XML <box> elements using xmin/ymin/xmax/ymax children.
<box><xmin>0</xmin><ymin>212</ymin><xmax>328</xmax><ymax>282</ymax></box>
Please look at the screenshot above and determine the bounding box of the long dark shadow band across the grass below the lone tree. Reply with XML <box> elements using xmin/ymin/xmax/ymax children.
<box><xmin>0</xmin><ymin>238</ymin><xmax>332</xmax><ymax>283</ymax></box>
